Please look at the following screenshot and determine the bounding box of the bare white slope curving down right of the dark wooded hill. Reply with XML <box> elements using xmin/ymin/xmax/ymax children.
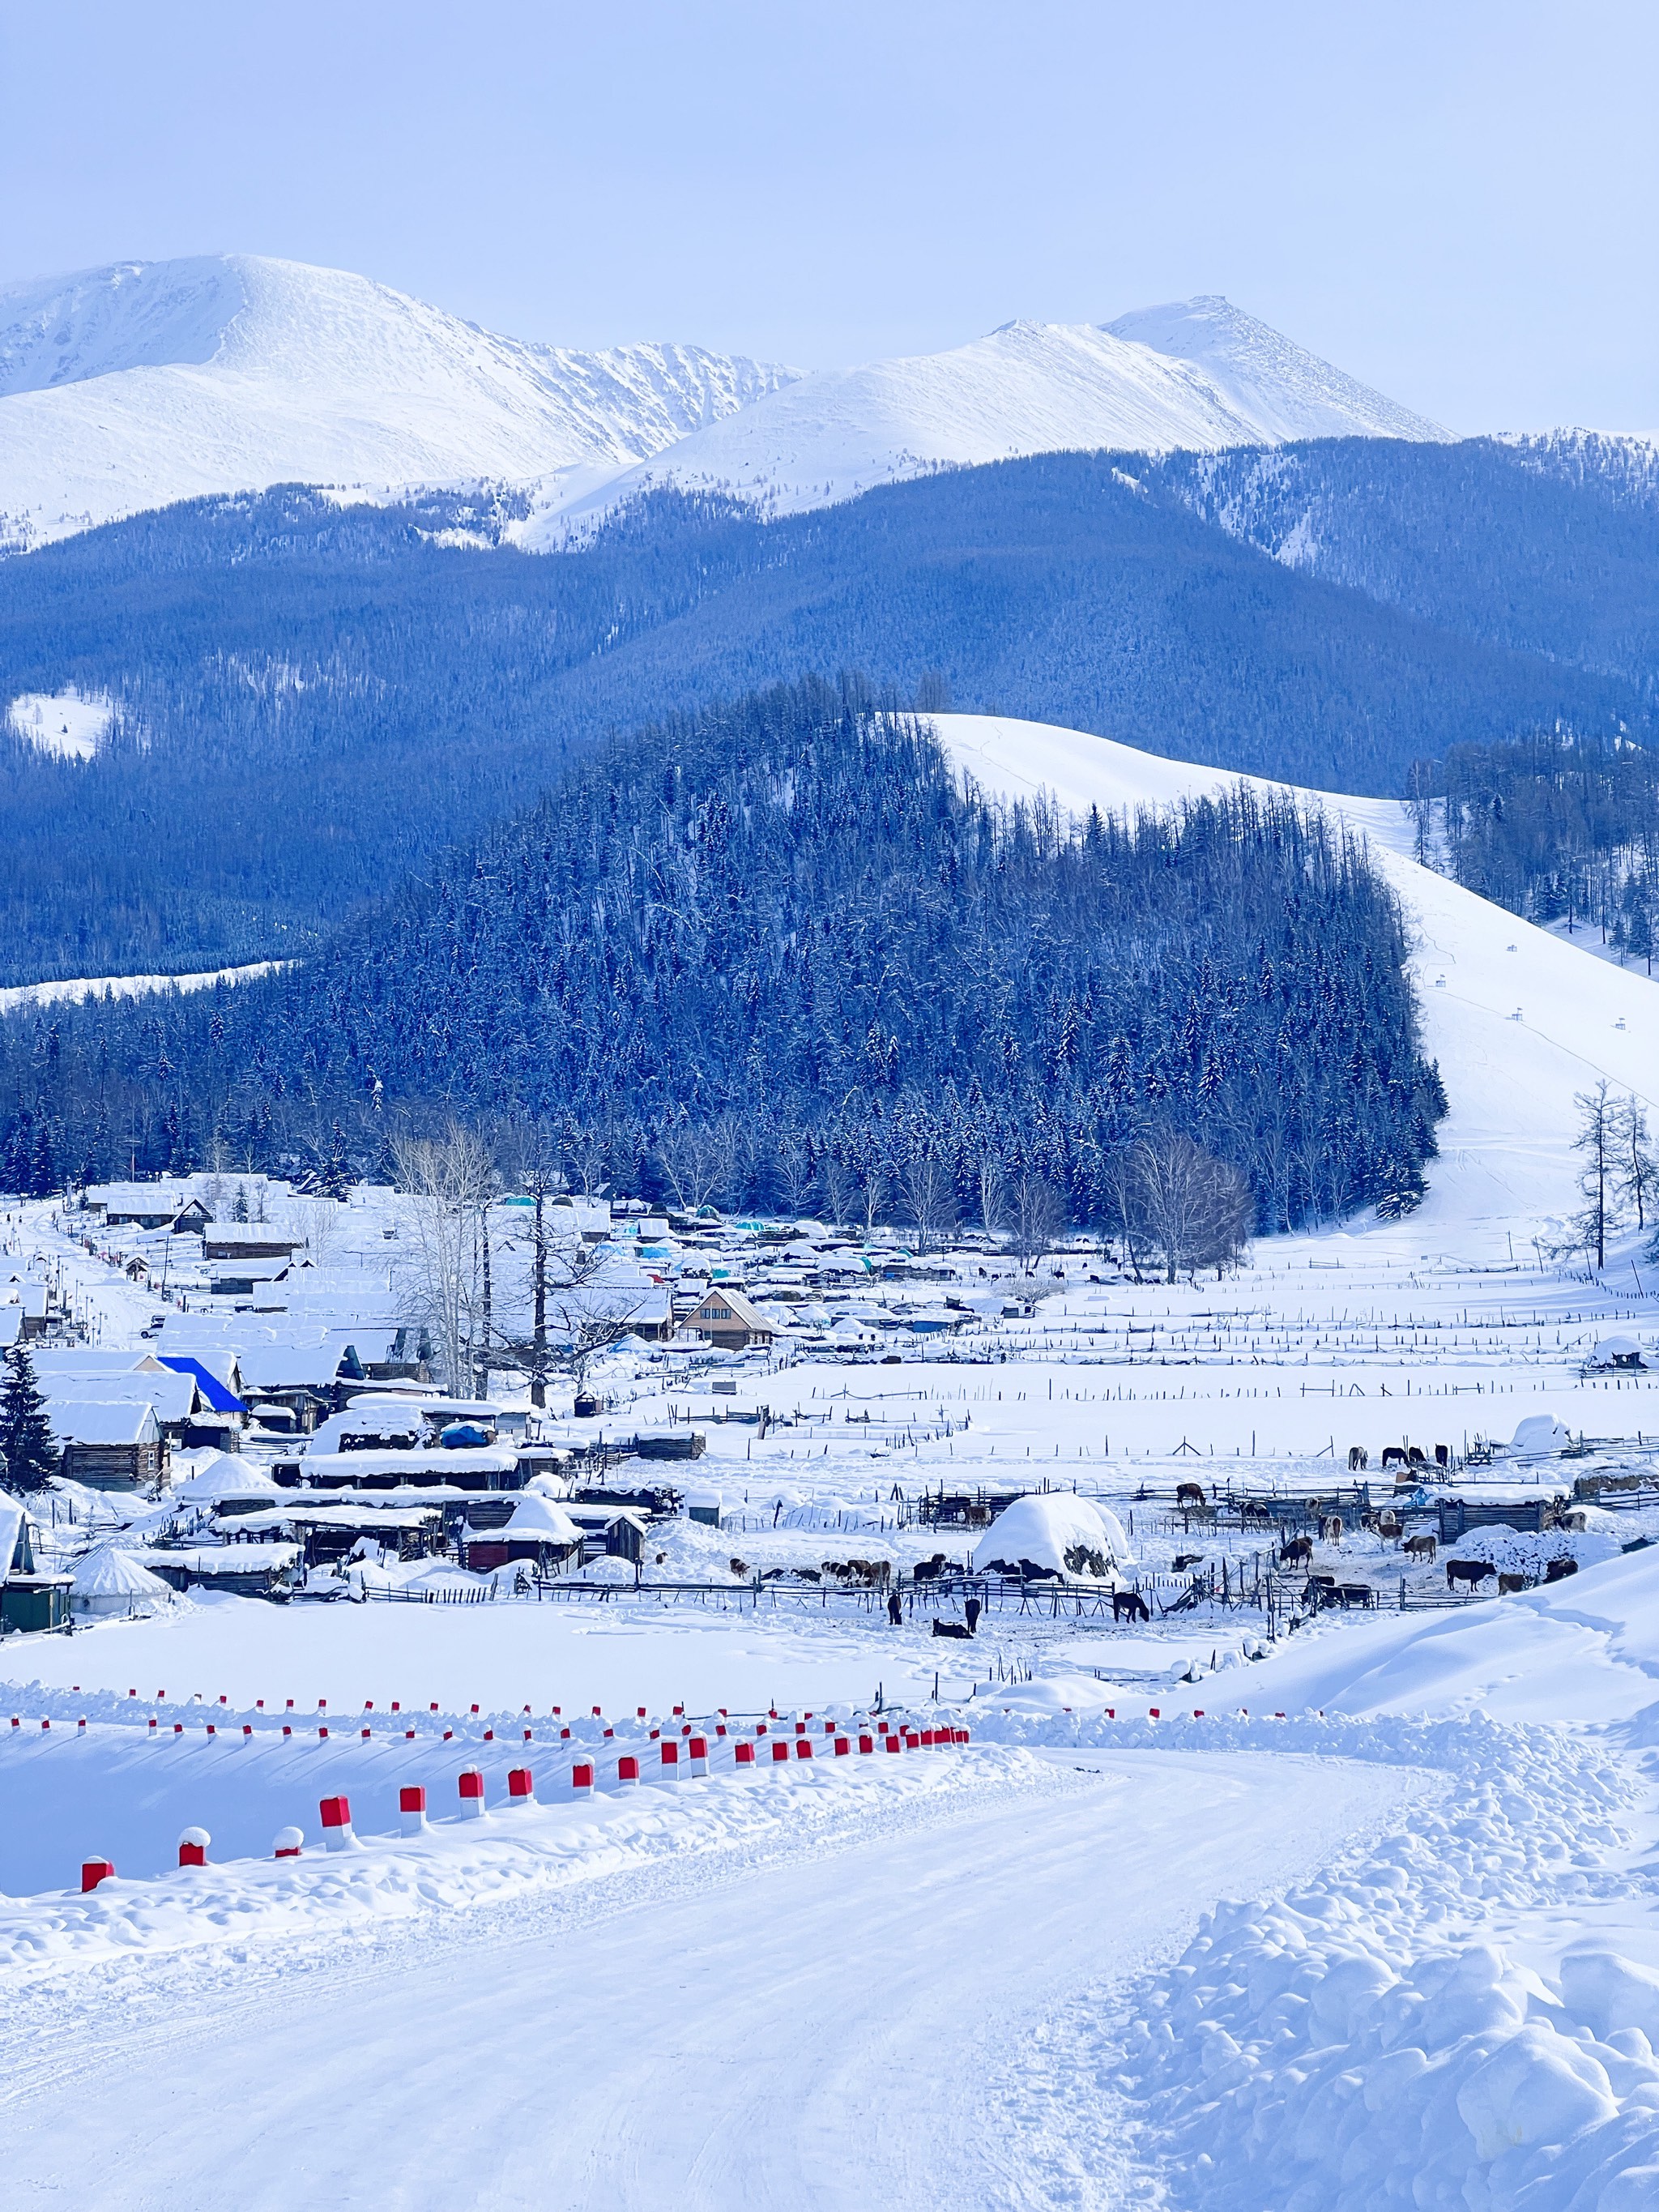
<box><xmin>929</xmin><ymin>715</ymin><xmax>1659</xmax><ymax>1257</ymax></box>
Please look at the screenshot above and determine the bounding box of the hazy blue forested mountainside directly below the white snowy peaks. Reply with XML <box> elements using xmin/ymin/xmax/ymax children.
<box><xmin>0</xmin><ymin>440</ymin><xmax>1659</xmax><ymax>982</ymax></box>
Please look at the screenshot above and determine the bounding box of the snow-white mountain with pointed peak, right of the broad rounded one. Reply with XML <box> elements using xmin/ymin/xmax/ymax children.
<box><xmin>524</xmin><ymin>299</ymin><xmax>1451</xmax><ymax>544</ymax></box>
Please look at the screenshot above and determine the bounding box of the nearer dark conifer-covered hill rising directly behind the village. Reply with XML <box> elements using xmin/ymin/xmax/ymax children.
<box><xmin>0</xmin><ymin>684</ymin><xmax>1444</xmax><ymax>1228</ymax></box>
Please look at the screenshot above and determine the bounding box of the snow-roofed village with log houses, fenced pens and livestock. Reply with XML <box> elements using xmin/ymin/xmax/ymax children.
<box><xmin>0</xmin><ymin>1175</ymin><xmax>1659</xmax><ymax>1676</ymax></box>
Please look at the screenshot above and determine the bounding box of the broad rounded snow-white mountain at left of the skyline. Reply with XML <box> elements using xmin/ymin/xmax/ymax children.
<box><xmin>0</xmin><ymin>254</ymin><xmax>796</xmax><ymax>544</ymax></box>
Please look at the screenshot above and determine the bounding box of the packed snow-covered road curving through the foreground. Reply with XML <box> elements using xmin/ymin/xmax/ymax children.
<box><xmin>0</xmin><ymin>1752</ymin><xmax>1422</xmax><ymax>2212</ymax></box>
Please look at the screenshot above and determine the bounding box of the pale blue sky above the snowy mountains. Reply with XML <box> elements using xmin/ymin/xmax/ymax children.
<box><xmin>0</xmin><ymin>0</ymin><xmax>1659</xmax><ymax>431</ymax></box>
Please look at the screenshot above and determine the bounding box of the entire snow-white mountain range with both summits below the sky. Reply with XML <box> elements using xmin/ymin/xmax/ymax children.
<box><xmin>0</xmin><ymin>254</ymin><xmax>1451</xmax><ymax>551</ymax></box>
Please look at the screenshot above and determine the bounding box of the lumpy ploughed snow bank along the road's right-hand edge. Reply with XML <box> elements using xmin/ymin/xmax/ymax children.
<box><xmin>975</xmin><ymin>1708</ymin><xmax>1659</xmax><ymax>2212</ymax></box>
